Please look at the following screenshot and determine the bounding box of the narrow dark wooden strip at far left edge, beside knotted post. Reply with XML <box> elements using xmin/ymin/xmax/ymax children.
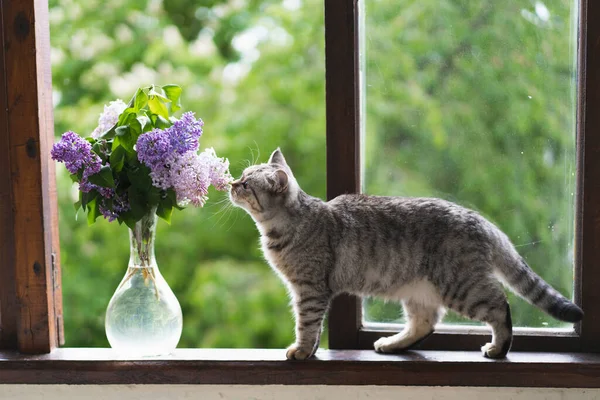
<box><xmin>0</xmin><ymin>0</ymin><xmax>17</xmax><ymax>349</ymax></box>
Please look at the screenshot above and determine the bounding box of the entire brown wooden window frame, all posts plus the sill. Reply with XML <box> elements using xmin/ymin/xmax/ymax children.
<box><xmin>0</xmin><ymin>0</ymin><xmax>600</xmax><ymax>388</ymax></box>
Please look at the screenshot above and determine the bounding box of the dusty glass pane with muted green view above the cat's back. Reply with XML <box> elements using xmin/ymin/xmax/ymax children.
<box><xmin>361</xmin><ymin>0</ymin><xmax>578</xmax><ymax>327</ymax></box>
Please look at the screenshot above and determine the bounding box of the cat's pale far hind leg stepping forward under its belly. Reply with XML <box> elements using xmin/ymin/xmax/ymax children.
<box><xmin>374</xmin><ymin>300</ymin><xmax>443</xmax><ymax>353</ymax></box>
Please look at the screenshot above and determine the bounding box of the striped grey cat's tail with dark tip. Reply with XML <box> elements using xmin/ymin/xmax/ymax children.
<box><xmin>497</xmin><ymin>255</ymin><xmax>583</xmax><ymax>322</ymax></box>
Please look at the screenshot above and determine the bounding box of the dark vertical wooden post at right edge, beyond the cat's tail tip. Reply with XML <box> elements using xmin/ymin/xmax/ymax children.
<box><xmin>575</xmin><ymin>1</ymin><xmax>600</xmax><ymax>352</ymax></box>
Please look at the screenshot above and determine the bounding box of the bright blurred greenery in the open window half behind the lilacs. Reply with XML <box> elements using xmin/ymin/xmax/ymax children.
<box><xmin>50</xmin><ymin>0</ymin><xmax>326</xmax><ymax>348</ymax></box>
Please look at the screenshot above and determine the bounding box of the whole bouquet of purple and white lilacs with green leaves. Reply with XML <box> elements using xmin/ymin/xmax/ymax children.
<box><xmin>51</xmin><ymin>85</ymin><xmax>232</xmax><ymax>229</ymax></box>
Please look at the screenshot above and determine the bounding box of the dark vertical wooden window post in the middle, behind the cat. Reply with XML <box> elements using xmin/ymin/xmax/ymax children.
<box><xmin>325</xmin><ymin>0</ymin><xmax>362</xmax><ymax>349</ymax></box>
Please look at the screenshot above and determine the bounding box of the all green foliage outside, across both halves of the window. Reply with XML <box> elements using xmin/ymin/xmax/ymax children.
<box><xmin>50</xmin><ymin>0</ymin><xmax>575</xmax><ymax>348</ymax></box>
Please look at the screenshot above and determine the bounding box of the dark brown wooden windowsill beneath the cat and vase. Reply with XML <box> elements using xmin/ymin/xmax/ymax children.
<box><xmin>0</xmin><ymin>348</ymin><xmax>600</xmax><ymax>388</ymax></box>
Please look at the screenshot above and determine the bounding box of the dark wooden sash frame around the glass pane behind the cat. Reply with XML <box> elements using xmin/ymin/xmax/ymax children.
<box><xmin>325</xmin><ymin>0</ymin><xmax>600</xmax><ymax>352</ymax></box>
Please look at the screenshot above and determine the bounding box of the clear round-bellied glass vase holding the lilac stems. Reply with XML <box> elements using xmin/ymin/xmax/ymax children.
<box><xmin>105</xmin><ymin>210</ymin><xmax>183</xmax><ymax>357</ymax></box>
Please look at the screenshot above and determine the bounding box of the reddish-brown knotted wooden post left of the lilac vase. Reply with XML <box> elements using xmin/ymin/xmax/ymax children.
<box><xmin>0</xmin><ymin>0</ymin><xmax>60</xmax><ymax>353</ymax></box>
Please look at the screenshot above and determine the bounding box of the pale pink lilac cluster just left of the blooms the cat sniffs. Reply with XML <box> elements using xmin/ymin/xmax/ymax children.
<box><xmin>171</xmin><ymin>151</ymin><xmax>210</xmax><ymax>207</ymax></box>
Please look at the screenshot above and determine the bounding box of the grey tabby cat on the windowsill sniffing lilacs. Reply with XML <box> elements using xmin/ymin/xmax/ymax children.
<box><xmin>229</xmin><ymin>148</ymin><xmax>583</xmax><ymax>360</ymax></box>
